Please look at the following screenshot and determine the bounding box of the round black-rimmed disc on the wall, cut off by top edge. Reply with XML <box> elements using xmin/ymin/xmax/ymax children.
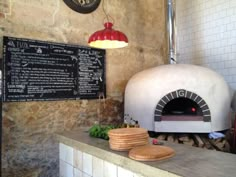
<box><xmin>63</xmin><ymin>0</ymin><xmax>101</xmax><ymax>14</ymax></box>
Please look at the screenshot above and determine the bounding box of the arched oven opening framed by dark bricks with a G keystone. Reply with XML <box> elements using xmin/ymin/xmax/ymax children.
<box><xmin>154</xmin><ymin>89</ymin><xmax>211</xmax><ymax>122</ymax></box>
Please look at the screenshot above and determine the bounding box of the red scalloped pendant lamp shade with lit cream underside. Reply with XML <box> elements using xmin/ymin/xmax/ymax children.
<box><xmin>88</xmin><ymin>22</ymin><xmax>128</xmax><ymax>49</ymax></box>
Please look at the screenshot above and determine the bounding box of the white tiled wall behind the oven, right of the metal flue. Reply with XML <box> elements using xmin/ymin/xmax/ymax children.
<box><xmin>176</xmin><ymin>0</ymin><xmax>236</xmax><ymax>90</ymax></box>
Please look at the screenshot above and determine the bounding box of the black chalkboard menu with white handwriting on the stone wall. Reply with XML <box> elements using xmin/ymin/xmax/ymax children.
<box><xmin>3</xmin><ymin>37</ymin><xmax>106</xmax><ymax>101</ymax></box>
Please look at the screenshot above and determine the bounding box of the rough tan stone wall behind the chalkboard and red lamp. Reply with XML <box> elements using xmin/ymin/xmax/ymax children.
<box><xmin>0</xmin><ymin>0</ymin><xmax>166</xmax><ymax>177</ymax></box>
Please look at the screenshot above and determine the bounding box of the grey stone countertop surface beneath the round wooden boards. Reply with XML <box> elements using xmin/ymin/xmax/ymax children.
<box><xmin>57</xmin><ymin>128</ymin><xmax>236</xmax><ymax>177</ymax></box>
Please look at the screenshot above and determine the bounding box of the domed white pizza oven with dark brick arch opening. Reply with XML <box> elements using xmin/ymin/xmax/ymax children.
<box><xmin>125</xmin><ymin>64</ymin><xmax>231</xmax><ymax>133</ymax></box>
